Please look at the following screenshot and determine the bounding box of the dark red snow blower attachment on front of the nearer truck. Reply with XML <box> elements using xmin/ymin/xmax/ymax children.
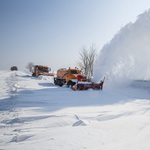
<box><xmin>72</xmin><ymin>77</ymin><xmax>105</xmax><ymax>91</ymax></box>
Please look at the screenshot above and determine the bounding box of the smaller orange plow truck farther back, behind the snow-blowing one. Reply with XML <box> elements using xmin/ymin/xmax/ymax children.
<box><xmin>32</xmin><ymin>65</ymin><xmax>54</xmax><ymax>77</ymax></box>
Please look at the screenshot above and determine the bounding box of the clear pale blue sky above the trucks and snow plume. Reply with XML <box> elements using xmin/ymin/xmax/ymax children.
<box><xmin>0</xmin><ymin>0</ymin><xmax>150</xmax><ymax>70</ymax></box>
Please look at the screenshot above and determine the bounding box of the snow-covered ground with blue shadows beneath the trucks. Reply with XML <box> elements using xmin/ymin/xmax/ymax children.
<box><xmin>0</xmin><ymin>71</ymin><xmax>150</xmax><ymax>150</ymax></box>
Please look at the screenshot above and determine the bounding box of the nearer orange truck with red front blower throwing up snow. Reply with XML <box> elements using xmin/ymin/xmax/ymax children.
<box><xmin>54</xmin><ymin>68</ymin><xmax>105</xmax><ymax>91</ymax></box>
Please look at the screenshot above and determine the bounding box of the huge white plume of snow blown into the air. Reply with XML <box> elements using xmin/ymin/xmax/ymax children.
<box><xmin>94</xmin><ymin>9</ymin><xmax>150</xmax><ymax>83</ymax></box>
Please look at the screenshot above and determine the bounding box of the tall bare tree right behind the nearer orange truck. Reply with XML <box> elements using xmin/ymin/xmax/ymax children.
<box><xmin>77</xmin><ymin>45</ymin><xmax>97</xmax><ymax>76</ymax></box>
